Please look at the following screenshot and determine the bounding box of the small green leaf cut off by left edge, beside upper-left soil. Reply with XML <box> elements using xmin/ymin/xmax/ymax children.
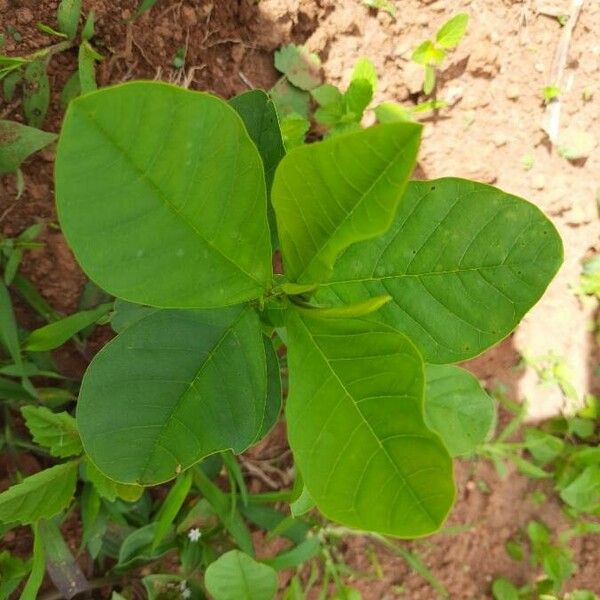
<box><xmin>0</xmin><ymin>120</ymin><xmax>56</xmax><ymax>175</ymax></box>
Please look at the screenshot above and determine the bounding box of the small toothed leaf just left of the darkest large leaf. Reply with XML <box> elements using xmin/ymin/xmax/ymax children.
<box><xmin>21</xmin><ymin>405</ymin><xmax>83</xmax><ymax>458</ymax></box>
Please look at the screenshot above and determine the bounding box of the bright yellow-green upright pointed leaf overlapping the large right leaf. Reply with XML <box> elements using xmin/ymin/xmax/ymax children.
<box><xmin>273</xmin><ymin>123</ymin><xmax>421</xmax><ymax>283</ymax></box>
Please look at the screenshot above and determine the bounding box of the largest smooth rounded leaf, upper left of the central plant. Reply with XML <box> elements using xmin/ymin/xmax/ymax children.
<box><xmin>56</xmin><ymin>82</ymin><xmax>271</xmax><ymax>308</ymax></box>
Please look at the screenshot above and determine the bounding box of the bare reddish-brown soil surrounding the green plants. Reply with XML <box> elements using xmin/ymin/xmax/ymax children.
<box><xmin>0</xmin><ymin>0</ymin><xmax>600</xmax><ymax>600</ymax></box>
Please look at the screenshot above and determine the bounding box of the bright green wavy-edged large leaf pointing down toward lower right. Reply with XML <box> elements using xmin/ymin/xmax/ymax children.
<box><xmin>287</xmin><ymin>312</ymin><xmax>454</xmax><ymax>537</ymax></box>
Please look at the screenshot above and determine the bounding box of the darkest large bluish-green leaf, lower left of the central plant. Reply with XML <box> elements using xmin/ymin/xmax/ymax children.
<box><xmin>77</xmin><ymin>307</ymin><xmax>267</xmax><ymax>485</ymax></box>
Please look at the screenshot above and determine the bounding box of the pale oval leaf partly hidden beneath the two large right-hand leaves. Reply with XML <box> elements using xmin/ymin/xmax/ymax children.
<box><xmin>425</xmin><ymin>365</ymin><xmax>495</xmax><ymax>456</ymax></box>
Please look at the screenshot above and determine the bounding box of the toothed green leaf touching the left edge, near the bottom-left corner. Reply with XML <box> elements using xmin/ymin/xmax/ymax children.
<box><xmin>0</xmin><ymin>461</ymin><xmax>78</xmax><ymax>525</ymax></box>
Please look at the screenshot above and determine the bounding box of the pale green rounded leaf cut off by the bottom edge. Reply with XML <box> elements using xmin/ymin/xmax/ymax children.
<box><xmin>205</xmin><ymin>550</ymin><xmax>277</xmax><ymax>600</ymax></box>
